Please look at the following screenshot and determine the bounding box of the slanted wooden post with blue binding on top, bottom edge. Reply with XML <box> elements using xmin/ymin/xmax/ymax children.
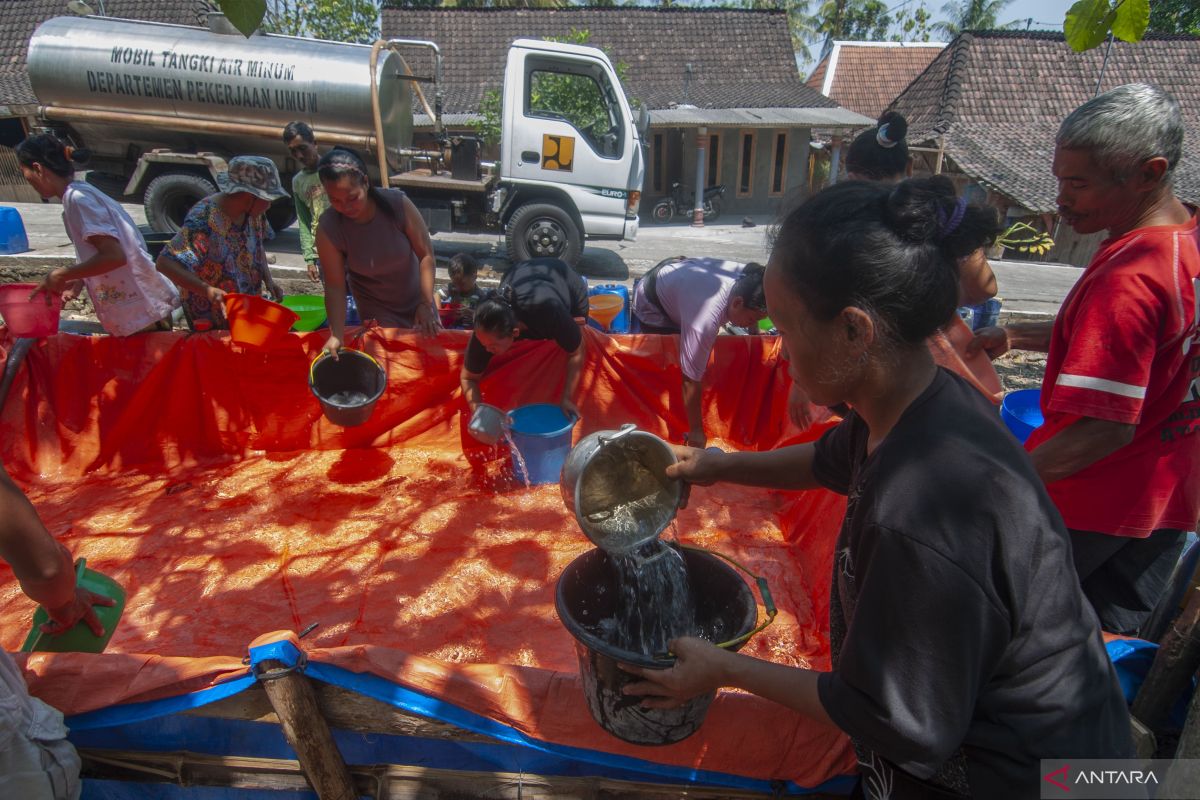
<box><xmin>259</xmin><ymin>658</ymin><xmax>358</xmax><ymax>800</ymax></box>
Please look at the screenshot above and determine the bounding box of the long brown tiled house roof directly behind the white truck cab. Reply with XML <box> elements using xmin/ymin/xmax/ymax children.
<box><xmin>383</xmin><ymin>7</ymin><xmax>836</xmax><ymax>113</ymax></box>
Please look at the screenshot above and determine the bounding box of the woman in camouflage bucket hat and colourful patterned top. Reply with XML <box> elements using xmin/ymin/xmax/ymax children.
<box><xmin>156</xmin><ymin>156</ymin><xmax>287</xmax><ymax>327</ymax></box>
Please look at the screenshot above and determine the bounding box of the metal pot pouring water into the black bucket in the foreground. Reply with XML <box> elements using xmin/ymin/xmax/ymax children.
<box><xmin>559</xmin><ymin>425</ymin><xmax>683</xmax><ymax>553</ymax></box>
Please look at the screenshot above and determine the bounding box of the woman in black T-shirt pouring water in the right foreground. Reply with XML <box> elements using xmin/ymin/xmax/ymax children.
<box><xmin>626</xmin><ymin>178</ymin><xmax>1133</xmax><ymax>800</ymax></box>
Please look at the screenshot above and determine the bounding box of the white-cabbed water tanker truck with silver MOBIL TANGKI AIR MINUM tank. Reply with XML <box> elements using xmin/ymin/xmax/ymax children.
<box><xmin>26</xmin><ymin>17</ymin><xmax>646</xmax><ymax>264</ymax></box>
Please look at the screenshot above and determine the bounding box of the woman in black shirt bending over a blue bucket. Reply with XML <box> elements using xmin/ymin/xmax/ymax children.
<box><xmin>460</xmin><ymin>258</ymin><xmax>588</xmax><ymax>416</ymax></box>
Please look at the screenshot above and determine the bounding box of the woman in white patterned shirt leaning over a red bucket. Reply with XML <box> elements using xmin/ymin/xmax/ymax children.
<box><xmin>17</xmin><ymin>133</ymin><xmax>179</xmax><ymax>336</ymax></box>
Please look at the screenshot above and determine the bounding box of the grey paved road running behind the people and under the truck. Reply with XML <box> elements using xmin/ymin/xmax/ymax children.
<box><xmin>0</xmin><ymin>203</ymin><xmax>1080</xmax><ymax>315</ymax></box>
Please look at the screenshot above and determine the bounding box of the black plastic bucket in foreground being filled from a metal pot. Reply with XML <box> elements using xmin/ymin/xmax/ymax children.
<box><xmin>554</xmin><ymin>549</ymin><xmax>758</xmax><ymax>745</ymax></box>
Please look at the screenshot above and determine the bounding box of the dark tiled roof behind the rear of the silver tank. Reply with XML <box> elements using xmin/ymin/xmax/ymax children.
<box><xmin>0</xmin><ymin>0</ymin><xmax>203</xmax><ymax>106</ymax></box>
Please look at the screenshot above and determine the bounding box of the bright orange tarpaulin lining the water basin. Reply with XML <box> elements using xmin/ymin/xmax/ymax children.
<box><xmin>0</xmin><ymin>330</ymin><xmax>854</xmax><ymax>786</ymax></box>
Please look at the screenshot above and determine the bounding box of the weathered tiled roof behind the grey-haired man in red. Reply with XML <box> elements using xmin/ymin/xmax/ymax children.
<box><xmin>892</xmin><ymin>31</ymin><xmax>1200</xmax><ymax>211</ymax></box>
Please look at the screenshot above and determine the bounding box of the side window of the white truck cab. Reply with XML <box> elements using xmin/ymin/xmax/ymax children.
<box><xmin>527</xmin><ymin>70</ymin><xmax>624</xmax><ymax>158</ymax></box>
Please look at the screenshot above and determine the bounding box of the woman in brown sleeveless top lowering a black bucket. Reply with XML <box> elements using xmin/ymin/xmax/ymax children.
<box><xmin>317</xmin><ymin>148</ymin><xmax>440</xmax><ymax>354</ymax></box>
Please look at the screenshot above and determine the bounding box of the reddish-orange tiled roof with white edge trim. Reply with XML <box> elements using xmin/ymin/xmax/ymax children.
<box><xmin>805</xmin><ymin>42</ymin><xmax>946</xmax><ymax>120</ymax></box>
